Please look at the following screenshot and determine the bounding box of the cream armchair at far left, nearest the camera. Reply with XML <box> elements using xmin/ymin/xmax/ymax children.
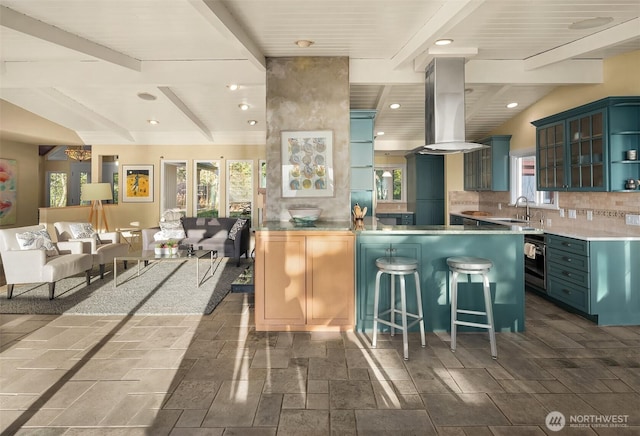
<box><xmin>0</xmin><ymin>226</ymin><xmax>93</xmax><ymax>300</ymax></box>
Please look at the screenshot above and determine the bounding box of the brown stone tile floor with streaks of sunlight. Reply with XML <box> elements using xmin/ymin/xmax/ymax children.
<box><xmin>0</xmin><ymin>294</ymin><xmax>640</xmax><ymax>436</ymax></box>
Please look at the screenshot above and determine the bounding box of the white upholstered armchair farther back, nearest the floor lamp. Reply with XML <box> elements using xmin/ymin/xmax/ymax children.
<box><xmin>53</xmin><ymin>221</ymin><xmax>129</xmax><ymax>279</ymax></box>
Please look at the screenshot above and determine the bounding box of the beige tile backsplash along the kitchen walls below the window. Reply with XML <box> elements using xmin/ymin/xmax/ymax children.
<box><xmin>449</xmin><ymin>191</ymin><xmax>640</xmax><ymax>234</ymax></box>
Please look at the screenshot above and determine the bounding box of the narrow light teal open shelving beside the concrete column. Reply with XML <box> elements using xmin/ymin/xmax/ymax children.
<box><xmin>350</xmin><ymin>110</ymin><xmax>376</xmax><ymax>214</ymax></box>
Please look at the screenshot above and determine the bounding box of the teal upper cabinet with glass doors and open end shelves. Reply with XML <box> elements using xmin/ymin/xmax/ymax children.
<box><xmin>533</xmin><ymin>97</ymin><xmax>640</xmax><ymax>191</ymax></box>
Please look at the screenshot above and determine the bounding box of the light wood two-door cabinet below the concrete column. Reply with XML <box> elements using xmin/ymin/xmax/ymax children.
<box><xmin>255</xmin><ymin>230</ymin><xmax>355</xmax><ymax>331</ymax></box>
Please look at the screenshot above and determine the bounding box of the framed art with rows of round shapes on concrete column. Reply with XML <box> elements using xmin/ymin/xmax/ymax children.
<box><xmin>281</xmin><ymin>130</ymin><xmax>333</xmax><ymax>197</ymax></box>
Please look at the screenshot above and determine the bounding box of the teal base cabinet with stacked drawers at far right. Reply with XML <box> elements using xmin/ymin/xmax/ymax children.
<box><xmin>547</xmin><ymin>235</ymin><xmax>640</xmax><ymax>325</ymax></box>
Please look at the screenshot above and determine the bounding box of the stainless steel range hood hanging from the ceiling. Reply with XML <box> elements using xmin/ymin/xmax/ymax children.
<box><xmin>413</xmin><ymin>58</ymin><xmax>486</xmax><ymax>154</ymax></box>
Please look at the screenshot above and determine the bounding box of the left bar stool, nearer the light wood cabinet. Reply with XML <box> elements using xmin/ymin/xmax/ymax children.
<box><xmin>371</xmin><ymin>257</ymin><xmax>426</xmax><ymax>360</ymax></box>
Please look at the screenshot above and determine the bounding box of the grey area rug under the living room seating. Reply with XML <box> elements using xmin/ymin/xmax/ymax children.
<box><xmin>0</xmin><ymin>258</ymin><xmax>248</xmax><ymax>315</ymax></box>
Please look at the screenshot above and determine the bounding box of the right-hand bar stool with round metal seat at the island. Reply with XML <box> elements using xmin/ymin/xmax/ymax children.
<box><xmin>447</xmin><ymin>256</ymin><xmax>498</xmax><ymax>359</ymax></box>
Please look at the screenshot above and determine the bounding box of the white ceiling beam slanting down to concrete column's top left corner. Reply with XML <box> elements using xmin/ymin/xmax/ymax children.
<box><xmin>189</xmin><ymin>0</ymin><xmax>267</xmax><ymax>72</ymax></box>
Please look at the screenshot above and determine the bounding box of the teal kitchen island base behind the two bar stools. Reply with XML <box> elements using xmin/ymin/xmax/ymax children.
<box><xmin>356</xmin><ymin>231</ymin><xmax>525</xmax><ymax>332</ymax></box>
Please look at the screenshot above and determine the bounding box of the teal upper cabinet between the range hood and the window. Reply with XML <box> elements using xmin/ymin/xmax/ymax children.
<box><xmin>464</xmin><ymin>135</ymin><xmax>511</xmax><ymax>191</ymax></box>
